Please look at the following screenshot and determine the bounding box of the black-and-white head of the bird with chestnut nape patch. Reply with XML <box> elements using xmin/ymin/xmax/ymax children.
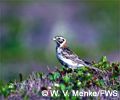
<box><xmin>53</xmin><ymin>36</ymin><xmax>67</xmax><ymax>48</ymax></box>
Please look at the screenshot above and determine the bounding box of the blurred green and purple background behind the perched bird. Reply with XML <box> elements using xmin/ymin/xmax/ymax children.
<box><xmin>0</xmin><ymin>0</ymin><xmax>120</xmax><ymax>81</ymax></box>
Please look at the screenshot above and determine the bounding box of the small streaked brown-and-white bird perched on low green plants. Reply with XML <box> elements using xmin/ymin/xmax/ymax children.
<box><xmin>53</xmin><ymin>36</ymin><xmax>103</xmax><ymax>72</ymax></box>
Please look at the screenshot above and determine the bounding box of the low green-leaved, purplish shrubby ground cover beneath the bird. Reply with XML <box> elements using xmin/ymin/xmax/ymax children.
<box><xmin>0</xmin><ymin>57</ymin><xmax>120</xmax><ymax>100</ymax></box>
